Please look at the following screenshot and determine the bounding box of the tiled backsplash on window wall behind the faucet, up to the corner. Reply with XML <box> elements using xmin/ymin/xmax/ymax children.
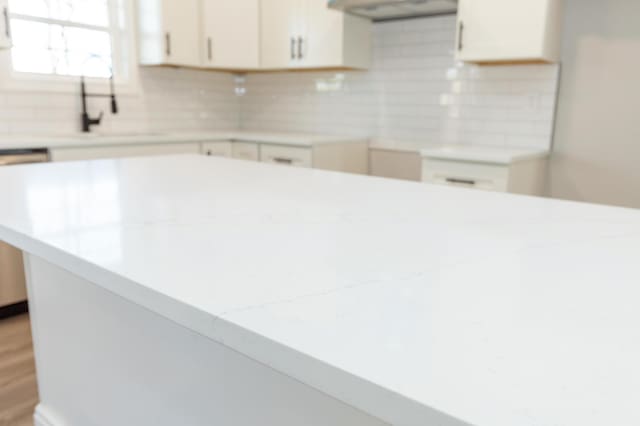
<box><xmin>0</xmin><ymin>68</ymin><xmax>239</xmax><ymax>136</ymax></box>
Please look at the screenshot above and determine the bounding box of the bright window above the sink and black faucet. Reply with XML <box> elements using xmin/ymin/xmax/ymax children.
<box><xmin>9</xmin><ymin>0</ymin><xmax>128</xmax><ymax>81</ymax></box>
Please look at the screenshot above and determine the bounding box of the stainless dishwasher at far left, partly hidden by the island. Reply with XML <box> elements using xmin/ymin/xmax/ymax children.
<box><xmin>0</xmin><ymin>149</ymin><xmax>49</xmax><ymax>318</ymax></box>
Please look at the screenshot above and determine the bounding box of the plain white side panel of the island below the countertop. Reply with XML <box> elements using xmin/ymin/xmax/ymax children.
<box><xmin>25</xmin><ymin>254</ymin><xmax>386</xmax><ymax>426</ymax></box>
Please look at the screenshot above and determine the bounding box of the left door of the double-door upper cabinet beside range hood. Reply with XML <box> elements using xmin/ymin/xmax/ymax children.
<box><xmin>260</xmin><ymin>0</ymin><xmax>304</xmax><ymax>68</ymax></box>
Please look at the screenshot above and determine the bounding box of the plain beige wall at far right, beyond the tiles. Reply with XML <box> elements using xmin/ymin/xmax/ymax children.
<box><xmin>550</xmin><ymin>0</ymin><xmax>640</xmax><ymax>208</ymax></box>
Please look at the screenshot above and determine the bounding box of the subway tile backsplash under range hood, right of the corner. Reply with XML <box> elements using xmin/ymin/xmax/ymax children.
<box><xmin>241</xmin><ymin>15</ymin><xmax>558</xmax><ymax>148</ymax></box>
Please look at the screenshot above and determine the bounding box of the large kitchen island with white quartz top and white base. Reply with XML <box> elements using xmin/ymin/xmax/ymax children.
<box><xmin>0</xmin><ymin>155</ymin><xmax>640</xmax><ymax>426</ymax></box>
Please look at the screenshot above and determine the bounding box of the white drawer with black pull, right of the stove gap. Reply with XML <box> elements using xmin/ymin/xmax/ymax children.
<box><xmin>422</xmin><ymin>159</ymin><xmax>509</xmax><ymax>192</ymax></box>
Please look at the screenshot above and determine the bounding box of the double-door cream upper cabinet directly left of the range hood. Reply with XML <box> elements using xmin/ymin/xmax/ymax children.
<box><xmin>261</xmin><ymin>0</ymin><xmax>372</xmax><ymax>69</ymax></box>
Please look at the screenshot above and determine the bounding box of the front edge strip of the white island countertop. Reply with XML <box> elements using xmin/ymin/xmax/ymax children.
<box><xmin>0</xmin><ymin>221</ymin><xmax>470</xmax><ymax>426</ymax></box>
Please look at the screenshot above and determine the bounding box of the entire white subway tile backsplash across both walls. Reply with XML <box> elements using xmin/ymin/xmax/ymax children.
<box><xmin>0</xmin><ymin>16</ymin><xmax>558</xmax><ymax>153</ymax></box>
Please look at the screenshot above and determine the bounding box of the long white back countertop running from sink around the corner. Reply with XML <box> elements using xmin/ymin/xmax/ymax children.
<box><xmin>0</xmin><ymin>130</ymin><xmax>366</xmax><ymax>150</ymax></box>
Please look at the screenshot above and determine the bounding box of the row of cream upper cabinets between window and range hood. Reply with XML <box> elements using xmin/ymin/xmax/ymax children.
<box><xmin>138</xmin><ymin>0</ymin><xmax>372</xmax><ymax>71</ymax></box>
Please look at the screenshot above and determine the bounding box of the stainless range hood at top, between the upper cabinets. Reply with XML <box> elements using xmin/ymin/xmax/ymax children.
<box><xmin>329</xmin><ymin>0</ymin><xmax>458</xmax><ymax>21</ymax></box>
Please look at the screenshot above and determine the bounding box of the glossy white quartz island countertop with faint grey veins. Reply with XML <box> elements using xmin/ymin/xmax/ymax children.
<box><xmin>0</xmin><ymin>156</ymin><xmax>640</xmax><ymax>426</ymax></box>
